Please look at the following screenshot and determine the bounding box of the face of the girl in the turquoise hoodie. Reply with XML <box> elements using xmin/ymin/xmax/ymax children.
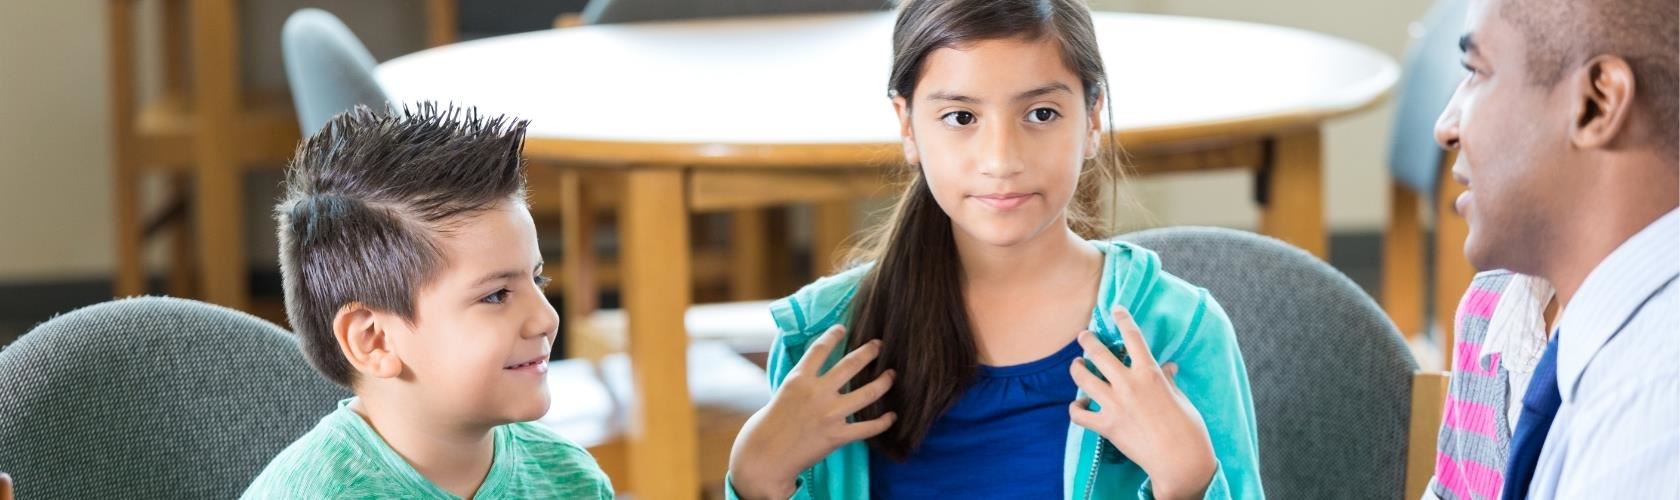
<box><xmin>892</xmin><ymin>37</ymin><xmax>1102</xmax><ymax>247</ymax></box>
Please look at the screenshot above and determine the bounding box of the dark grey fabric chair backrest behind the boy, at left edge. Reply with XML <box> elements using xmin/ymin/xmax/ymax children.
<box><xmin>0</xmin><ymin>297</ymin><xmax>349</xmax><ymax>498</ymax></box>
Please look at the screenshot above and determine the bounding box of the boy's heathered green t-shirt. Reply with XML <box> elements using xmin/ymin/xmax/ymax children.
<box><xmin>240</xmin><ymin>399</ymin><xmax>613</xmax><ymax>498</ymax></box>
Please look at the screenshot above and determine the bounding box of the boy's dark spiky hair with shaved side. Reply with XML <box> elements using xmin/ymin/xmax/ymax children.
<box><xmin>274</xmin><ymin>102</ymin><xmax>528</xmax><ymax>386</ymax></box>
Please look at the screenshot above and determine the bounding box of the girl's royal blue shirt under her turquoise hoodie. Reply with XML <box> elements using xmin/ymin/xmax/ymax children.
<box><xmin>869</xmin><ymin>337</ymin><xmax>1082</xmax><ymax>498</ymax></box>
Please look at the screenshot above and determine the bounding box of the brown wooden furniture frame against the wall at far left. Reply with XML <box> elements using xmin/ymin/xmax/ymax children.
<box><xmin>106</xmin><ymin>0</ymin><xmax>457</xmax><ymax>309</ymax></box>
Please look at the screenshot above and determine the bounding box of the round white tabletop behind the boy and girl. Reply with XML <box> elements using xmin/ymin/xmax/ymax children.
<box><xmin>378</xmin><ymin>12</ymin><xmax>1398</xmax><ymax>156</ymax></box>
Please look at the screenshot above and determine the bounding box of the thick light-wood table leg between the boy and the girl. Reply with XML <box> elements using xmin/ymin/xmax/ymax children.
<box><xmin>620</xmin><ymin>169</ymin><xmax>701</xmax><ymax>498</ymax></box>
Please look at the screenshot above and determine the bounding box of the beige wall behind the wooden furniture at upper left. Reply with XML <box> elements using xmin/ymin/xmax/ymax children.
<box><xmin>0</xmin><ymin>0</ymin><xmax>425</xmax><ymax>282</ymax></box>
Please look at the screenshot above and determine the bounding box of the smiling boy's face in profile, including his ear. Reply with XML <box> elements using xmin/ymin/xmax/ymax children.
<box><xmin>386</xmin><ymin>201</ymin><xmax>559</xmax><ymax>426</ymax></box>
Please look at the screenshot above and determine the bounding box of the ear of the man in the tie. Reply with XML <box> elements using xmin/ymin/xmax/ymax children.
<box><xmin>1562</xmin><ymin>55</ymin><xmax>1638</xmax><ymax>149</ymax></box>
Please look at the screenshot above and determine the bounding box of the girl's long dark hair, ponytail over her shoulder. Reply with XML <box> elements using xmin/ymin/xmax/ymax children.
<box><xmin>850</xmin><ymin>0</ymin><xmax>1122</xmax><ymax>460</ymax></box>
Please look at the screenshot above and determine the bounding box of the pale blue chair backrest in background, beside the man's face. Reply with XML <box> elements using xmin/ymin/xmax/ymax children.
<box><xmin>1388</xmin><ymin>0</ymin><xmax>1470</xmax><ymax>200</ymax></box>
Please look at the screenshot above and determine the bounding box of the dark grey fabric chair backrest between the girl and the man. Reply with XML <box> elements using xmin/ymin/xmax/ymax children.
<box><xmin>1119</xmin><ymin>228</ymin><xmax>1418</xmax><ymax>498</ymax></box>
